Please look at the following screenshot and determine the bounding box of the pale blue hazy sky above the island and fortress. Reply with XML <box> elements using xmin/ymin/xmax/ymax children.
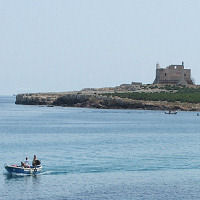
<box><xmin>0</xmin><ymin>0</ymin><xmax>200</xmax><ymax>95</ymax></box>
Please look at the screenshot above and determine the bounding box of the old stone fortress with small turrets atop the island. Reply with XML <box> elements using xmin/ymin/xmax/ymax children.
<box><xmin>153</xmin><ymin>62</ymin><xmax>193</xmax><ymax>85</ymax></box>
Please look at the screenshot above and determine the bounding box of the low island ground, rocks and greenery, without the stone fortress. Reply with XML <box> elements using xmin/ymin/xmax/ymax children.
<box><xmin>15</xmin><ymin>84</ymin><xmax>200</xmax><ymax>111</ymax></box>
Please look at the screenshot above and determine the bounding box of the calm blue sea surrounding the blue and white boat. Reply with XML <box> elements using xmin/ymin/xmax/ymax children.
<box><xmin>0</xmin><ymin>97</ymin><xmax>200</xmax><ymax>200</ymax></box>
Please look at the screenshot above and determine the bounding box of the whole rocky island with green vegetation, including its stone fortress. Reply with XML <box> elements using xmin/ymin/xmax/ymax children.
<box><xmin>16</xmin><ymin>62</ymin><xmax>200</xmax><ymax>113</ymax></box>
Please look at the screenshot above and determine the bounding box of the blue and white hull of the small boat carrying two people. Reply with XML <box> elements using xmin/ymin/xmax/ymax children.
<box><xmin>5</xmin><ymin>165</ymin><xmax>42</xmax><ymax>175</ymax></box>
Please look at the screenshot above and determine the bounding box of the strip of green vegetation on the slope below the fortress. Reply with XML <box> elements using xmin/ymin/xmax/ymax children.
<box><xmin>105</xmin><ymin>86</ymin><xmax>200</xmax><ymax>103</ymax></box>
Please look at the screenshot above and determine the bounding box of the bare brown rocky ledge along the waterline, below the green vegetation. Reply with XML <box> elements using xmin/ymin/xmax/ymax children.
<box><xmin>15</xmin><ymin>92</ymin><xmax>200</xmax><ymax>111</ymax></box>
